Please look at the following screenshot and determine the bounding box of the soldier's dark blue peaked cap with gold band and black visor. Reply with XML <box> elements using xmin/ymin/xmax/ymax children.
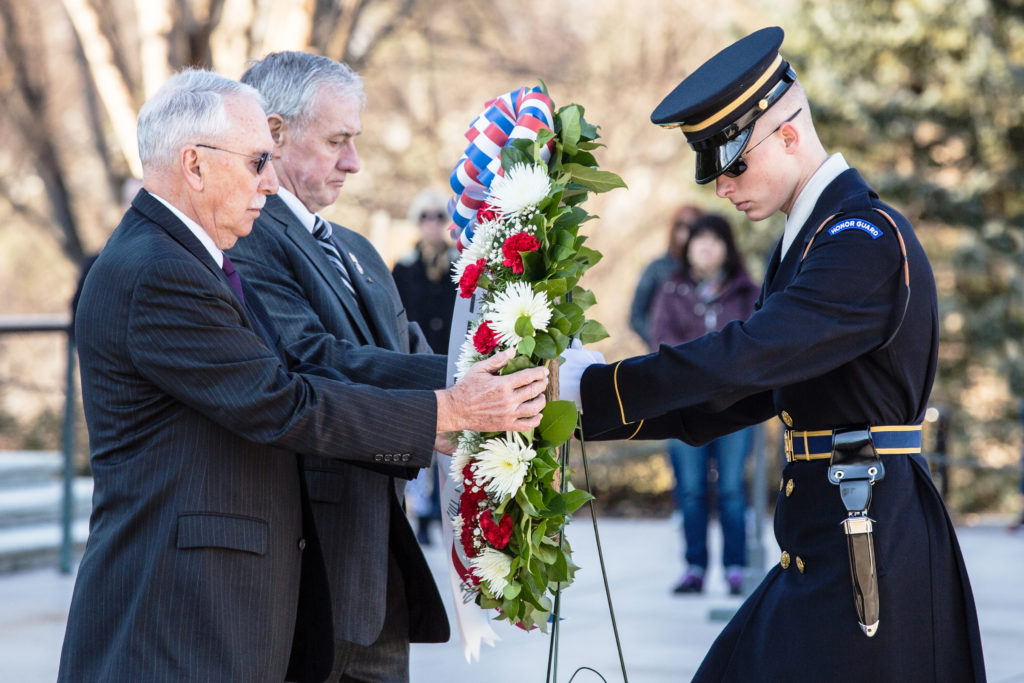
<box><xmin>650</xmin><ymin>27</ymin><xmax>797</xmax><ymax>184</ymax></box>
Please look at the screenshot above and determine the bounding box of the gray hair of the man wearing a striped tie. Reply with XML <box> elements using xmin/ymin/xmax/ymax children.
<box><xmin>242</xmin><ymin>51</ymin><xmax>367</xmax><ymax>129</ymax></box>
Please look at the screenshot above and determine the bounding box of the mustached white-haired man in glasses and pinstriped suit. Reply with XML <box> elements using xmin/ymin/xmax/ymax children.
<box><xmin>59</xmin><ymin>65</ymin><xmax>545</xmax><ymax>683</ymax></box>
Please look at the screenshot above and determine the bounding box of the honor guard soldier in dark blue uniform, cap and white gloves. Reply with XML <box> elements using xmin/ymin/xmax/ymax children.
<box><xmin>560</xmin><ymin>28</ymin><xmax>985</xmax><ymax>683</ymax></box>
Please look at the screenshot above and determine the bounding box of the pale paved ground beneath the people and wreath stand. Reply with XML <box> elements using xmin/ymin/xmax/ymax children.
<box><xmin>0</xmin><ymin>517</ymin><xmax>1024</xmax><ymax>683</ymax></box>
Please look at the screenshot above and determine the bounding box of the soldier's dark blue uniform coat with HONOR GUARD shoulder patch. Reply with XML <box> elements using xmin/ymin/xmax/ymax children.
<box><xmin>581</xmin><ymin>169</ymin><xmax>985</xmax><ymax>683</ymax></box>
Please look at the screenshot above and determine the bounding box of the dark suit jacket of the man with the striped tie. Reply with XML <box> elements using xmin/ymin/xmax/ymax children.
<box><xmin>230</xmin><ymin>197</ymin><xmax>450</xmax><ymax>645</ymax></box>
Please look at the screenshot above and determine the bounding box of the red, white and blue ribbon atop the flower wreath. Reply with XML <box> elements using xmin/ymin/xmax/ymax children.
<box><xmin>449</xmin><ymin>87</ymin><xmax>555</xmax><ymax>251</ymax></box>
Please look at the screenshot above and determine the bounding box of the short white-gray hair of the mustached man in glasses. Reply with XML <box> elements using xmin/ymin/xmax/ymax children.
<box><xmin>138</xmin><ymin>69</ymin><xmax>266</xmax><ymax>168</ymax></box>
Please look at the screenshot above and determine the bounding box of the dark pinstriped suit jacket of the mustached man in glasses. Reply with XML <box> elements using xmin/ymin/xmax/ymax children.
<box><xmin>59</xmin><ymin>190</ymin><xmax>436</xmax><ymax>683</ymax></box>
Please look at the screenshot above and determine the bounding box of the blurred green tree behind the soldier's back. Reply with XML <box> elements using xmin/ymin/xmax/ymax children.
<box><xmin>784</xmin><ymin>0</ymin><xmax>1024</xmax><ymax>507</ymax></box>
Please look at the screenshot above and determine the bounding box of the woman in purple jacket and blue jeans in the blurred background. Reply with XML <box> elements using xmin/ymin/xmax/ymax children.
<box><xmin>648</xmin><ymin>214</ymin><xmax>760</xmax><ymax>595</ymax></box>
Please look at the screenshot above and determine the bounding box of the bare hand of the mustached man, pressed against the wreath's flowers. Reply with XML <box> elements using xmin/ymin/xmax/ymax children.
<box><xmin>436</xmin><ymin>349</ymin><xmax>548</xmax><ymax>432</ymax></box>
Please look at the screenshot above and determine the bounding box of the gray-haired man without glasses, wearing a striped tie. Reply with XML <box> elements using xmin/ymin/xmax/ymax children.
<box><xmin>231</xmin><ymin>52</ymin><xmax>450</xmax><ymax>682</ymax></box>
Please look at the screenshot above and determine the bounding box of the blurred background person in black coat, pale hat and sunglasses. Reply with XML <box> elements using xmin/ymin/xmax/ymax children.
<box><xmin>391</xmin><ymin>189</ymin><xmax>459</xmax><ymax>546</ymax></box>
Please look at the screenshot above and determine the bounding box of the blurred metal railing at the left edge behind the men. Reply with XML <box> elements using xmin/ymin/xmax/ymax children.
<box><xmin>0</xmin><ymin>313</ymin><xmax>78</xmax><ymax>573</ymax></box>
